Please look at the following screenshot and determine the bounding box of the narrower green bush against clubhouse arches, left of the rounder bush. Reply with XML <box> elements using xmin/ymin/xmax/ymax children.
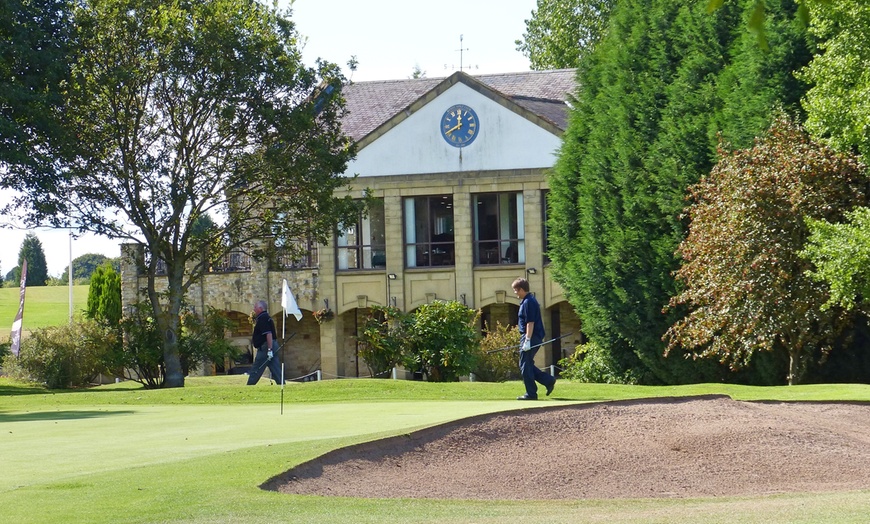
<box><xmin>357</xmin><ymin>306</ymin><xmax>411</xmax><ymax>378</ymax></box>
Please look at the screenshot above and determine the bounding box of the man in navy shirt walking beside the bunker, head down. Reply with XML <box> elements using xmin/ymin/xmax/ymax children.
<box><xmin>511</xmin><ymin>278</ymin><xmax>556</xmax><ymax>400</ymax></box>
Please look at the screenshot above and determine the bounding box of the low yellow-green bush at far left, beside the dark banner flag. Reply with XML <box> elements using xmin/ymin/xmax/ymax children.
<box><xmin>3</xmin><ymin>320</ymin><xmax>118</xmax><ymax>389</ymax></box>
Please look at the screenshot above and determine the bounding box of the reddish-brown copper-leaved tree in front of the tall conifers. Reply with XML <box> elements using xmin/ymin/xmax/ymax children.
<box><xmin>664</xmin><ymin>116</ymin><xmax>868</xmax><ymax>384</ymax></box>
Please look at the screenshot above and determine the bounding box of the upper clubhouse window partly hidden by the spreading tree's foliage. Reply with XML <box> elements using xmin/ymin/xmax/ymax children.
<box><xmin>336</xmin><ymin>198</ymin><xmax>387</xmax><ymax>269</ymax></box>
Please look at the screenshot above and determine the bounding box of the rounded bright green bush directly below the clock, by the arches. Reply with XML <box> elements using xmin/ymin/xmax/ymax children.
<box><xmin>403</xmin><ymin>300</ymin><xmax>479</xmax><ymax>382</ymax></box>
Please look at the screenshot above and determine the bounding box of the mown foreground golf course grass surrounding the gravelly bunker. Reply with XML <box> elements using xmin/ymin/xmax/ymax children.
<box><xmin>0</xmin><ymin>376</ymin><xmax>870</xmax><ymax>523</ymax></box>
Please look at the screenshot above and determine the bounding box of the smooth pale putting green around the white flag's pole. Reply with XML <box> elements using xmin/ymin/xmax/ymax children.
<box><xmin>0</xmin><ymin>401</ymin><xmax>553</xmax><ymax>491</ymax></box>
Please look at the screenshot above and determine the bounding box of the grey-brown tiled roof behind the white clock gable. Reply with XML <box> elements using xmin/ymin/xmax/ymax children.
<box><xmin>342</xmin><ymin>69</ymin><xmax>576</xmax><ymax>142</ymax></box>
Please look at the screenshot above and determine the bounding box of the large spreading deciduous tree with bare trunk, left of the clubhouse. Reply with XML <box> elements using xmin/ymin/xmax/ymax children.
<box><xmin>2</xmin><ymin>0</ymin><xmax>359</xmax><ymax>387</ymax></box>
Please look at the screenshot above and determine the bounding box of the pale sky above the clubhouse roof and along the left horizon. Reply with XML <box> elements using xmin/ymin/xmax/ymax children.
<box><xmin>0</xmin><ymin>0</ymin><xmax>537</xmax><ymax>277</ymax></box>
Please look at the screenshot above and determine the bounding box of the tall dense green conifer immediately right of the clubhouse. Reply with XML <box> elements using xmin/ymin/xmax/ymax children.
<box><xmin>550</xmin><ymin>0</ymin><xmax>809</xmax><ymax>383</ymax></box>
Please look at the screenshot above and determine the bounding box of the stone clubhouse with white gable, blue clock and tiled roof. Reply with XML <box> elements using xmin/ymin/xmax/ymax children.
<box><xmin>121</xmin><ymin>70</ymin><xmax>580</xmax><ymax>379</ymax></box>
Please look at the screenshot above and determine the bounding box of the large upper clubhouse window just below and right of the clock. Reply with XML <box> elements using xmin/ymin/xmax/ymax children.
<box><xmin>473</xmin><ymin>193</ymin><xmax>526</xmax><ymax>265</ymax></box>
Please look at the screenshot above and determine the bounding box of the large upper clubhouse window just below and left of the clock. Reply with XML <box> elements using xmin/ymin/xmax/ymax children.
<box><xmin>405</xmin><ymin>195</ymin><xmax>455</xmax><ymax>267</ymax></box>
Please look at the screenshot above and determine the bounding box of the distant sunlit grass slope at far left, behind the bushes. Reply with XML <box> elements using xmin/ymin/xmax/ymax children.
<box><xmin>0</xmin><ymin>286</ymin><xmax>88</xmax><ymax>341</ymax></box>
